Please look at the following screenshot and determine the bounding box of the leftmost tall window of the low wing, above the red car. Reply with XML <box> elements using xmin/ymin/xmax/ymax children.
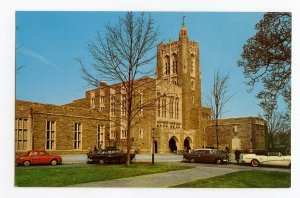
<box><xmin>15</xmin><ymin>119</ymin><xmax>28</xmax><ymax>150</ymax></box>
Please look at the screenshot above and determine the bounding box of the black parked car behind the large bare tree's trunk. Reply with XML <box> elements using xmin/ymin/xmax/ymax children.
<box><xmin>87</xmin><ymin>148</ymin><xmax>135</xmax><ymax>164</ymax></box>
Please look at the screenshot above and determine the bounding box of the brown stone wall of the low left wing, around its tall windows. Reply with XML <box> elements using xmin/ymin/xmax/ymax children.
<box><xmin>16</xmin><ymin>101</ymin><xmax>108</xmax><ymax>153</ymax></box>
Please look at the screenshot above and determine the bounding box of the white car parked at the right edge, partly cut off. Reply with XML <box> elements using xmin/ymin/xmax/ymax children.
<box><xmin>242</xmin><ymin>152</ymin><xmax>291</xmax><ymax>167</ymax></box>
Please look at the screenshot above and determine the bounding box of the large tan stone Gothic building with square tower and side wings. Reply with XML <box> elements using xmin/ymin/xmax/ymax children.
<box><xmin>16</xmin><ymin>23</ymin><xmax>265</xmax><ymax>153</ymax></box>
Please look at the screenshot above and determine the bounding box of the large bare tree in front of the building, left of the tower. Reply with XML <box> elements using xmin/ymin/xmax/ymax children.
<box><xmin>77</xmin><ymin>12</ymin><xmax>158</xmax><ymax>165</ymax></box>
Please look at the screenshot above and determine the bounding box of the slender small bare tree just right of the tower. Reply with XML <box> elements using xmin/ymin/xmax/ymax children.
<box><xmin>206</xmin><ymin>72</ymin><xmax>232</xmax><ymax>149</ymax></box>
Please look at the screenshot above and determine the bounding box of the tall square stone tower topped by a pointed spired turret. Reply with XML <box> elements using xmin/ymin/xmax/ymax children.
<box><xmin>156</xmin><ymin>19</ymin><xmax>201</xmax><ymax>130</ymax></box>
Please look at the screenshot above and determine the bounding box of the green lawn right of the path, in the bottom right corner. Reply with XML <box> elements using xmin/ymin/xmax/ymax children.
<box><xmin>173</xmin><ymin>171</ymin><xmax>291</xmax><ymax>188</ymax></box>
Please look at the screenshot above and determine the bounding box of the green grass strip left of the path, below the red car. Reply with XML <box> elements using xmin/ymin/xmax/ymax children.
<box><xmin>15</xmin><ymin>163</ymin><xmax>192</xmax><ymax>187</ymax></box>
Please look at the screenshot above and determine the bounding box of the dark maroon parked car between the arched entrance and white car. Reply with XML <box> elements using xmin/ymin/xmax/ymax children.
<box><xmin>183</xmin><ymin>149</ymin><xmax>227</xmax><ymax>164</ymax></box>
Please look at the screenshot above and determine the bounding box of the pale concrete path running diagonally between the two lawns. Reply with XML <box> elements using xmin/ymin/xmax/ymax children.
<box><xmin>71</xmin><ymin>166</ymin><xmax>239</xmax><ymax>188</ymax></box>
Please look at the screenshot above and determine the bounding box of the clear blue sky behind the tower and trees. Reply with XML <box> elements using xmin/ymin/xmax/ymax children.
<box><xmin>16</xmin><ymin>11</ymin><xmax>272</xmax><ymax>118</ymax></box>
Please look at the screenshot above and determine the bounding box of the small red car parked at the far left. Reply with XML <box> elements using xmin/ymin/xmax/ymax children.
<box><xmin>16</xmin><ymin>149</ymin><xmax>62</xmax><ymax>166</ymax></box>
